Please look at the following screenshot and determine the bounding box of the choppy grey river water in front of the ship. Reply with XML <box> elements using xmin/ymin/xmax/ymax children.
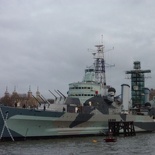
<box><xmin>0</xmin><ymin>133</ymin><xmax>155</xmax><ymax>155</ymax></box>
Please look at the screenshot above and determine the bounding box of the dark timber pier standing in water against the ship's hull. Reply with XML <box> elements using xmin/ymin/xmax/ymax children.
<box><xmin>108</xmin><ymin>120</ymin><xmax>136</xmax><ymax>137</ymax></box>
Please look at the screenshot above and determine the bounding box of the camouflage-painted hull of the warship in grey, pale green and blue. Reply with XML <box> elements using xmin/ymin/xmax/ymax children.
<box><xmin>0</xmin><ymin>106</ymin><xmax>155</xmax><ymax>139</ymax></box>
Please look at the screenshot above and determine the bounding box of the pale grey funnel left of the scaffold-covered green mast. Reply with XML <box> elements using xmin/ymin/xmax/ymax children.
<box><xmin>121</xmin><ymin>84</ymin><xmax>130</xmax><ymax>114</ymax></box>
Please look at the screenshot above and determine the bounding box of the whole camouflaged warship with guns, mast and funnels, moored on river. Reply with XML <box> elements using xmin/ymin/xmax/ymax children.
<box><xmin>0</xmin><ymin>41</ymin><xmax>155</xmax><ymax>141</ymax></box>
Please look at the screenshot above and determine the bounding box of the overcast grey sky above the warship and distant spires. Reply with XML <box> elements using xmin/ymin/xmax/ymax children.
<box><xmin>0</xmin><ymin>0</ymin><xmax>155</xmax><ymax>97</ymax></box>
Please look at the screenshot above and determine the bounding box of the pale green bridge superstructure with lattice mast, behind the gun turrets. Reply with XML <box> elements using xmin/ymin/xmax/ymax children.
<box><xmin>68</xmin><ymin>44</ymin><xmax>110</xmax><ymax>105</ymax></box>
